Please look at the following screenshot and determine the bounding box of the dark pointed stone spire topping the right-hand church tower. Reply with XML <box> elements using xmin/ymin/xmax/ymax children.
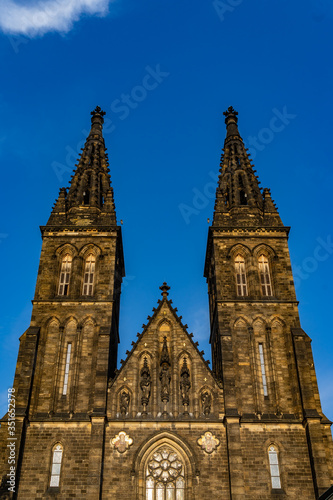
<box><xmin>213</xmin><ymin>106</ymin><xmax>282</xmax><ymax>226</ymax></box>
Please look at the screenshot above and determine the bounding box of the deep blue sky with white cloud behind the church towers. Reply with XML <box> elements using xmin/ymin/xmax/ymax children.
<box><xmin>0</xmin><ymin>0</ymin><xmax>333</xmax><ymax>419</ymax></box>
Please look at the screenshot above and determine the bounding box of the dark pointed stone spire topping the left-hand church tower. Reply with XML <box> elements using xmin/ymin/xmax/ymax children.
<box><xmin>48</xmin><ymin>106</ymin><xmax>116</xmax><ymax>226</ymax></box>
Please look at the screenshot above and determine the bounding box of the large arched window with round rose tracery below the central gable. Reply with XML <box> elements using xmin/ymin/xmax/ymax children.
<box><xmin>145</xmin><ymin>445</ymin><xmax>185</xmax><ymax>500</ymax></box>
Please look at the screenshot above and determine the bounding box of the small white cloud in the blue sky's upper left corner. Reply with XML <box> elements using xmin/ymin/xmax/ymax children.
<box><xmin>0</xmin><ymin>0</ymin><xmax>111</xmax><ymax>37</ymax></box>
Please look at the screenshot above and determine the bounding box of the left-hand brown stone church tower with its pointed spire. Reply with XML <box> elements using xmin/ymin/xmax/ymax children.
<box><xmin>1</xmin><ymin>107</ymin><xmax>124</xmax><ymax>498</ymax></box>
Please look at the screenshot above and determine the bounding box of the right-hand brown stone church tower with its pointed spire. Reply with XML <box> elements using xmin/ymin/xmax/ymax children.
<box><xmin>205</xmin><ymin>107</ymin><xmax>333</xmax><ymax>500</ymax></box>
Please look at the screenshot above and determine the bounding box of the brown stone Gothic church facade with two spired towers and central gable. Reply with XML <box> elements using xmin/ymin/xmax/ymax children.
<box><xmin>0</xmin><ymin>107</ymin><xmax>333</xmax><ymax>500</ymax></box>
